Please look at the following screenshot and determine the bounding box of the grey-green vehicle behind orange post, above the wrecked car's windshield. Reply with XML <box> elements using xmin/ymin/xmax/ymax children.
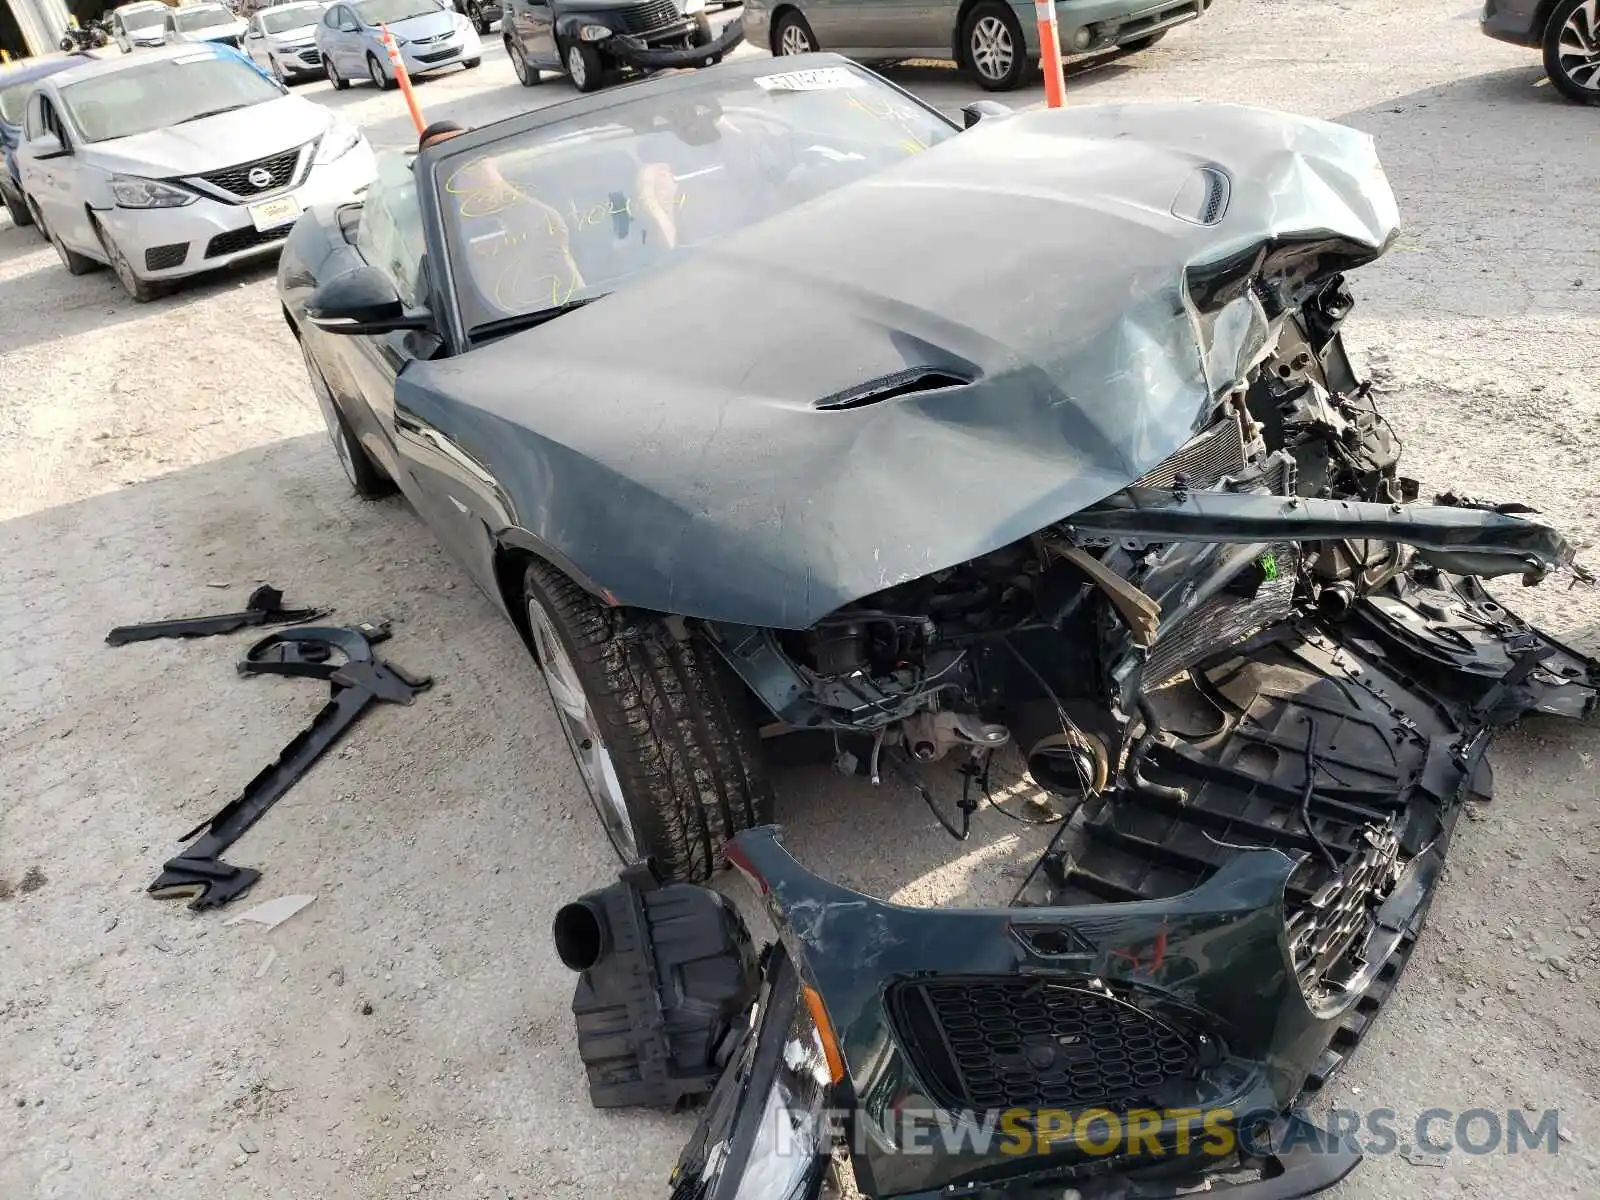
<box><xmin>744</xmin><ymin>0</ymin><xmax>1211</xmax><ymax>91</ymax></box>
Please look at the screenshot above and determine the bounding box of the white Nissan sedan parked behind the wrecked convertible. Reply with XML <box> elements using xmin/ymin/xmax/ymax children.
<box><xmin>16</xmin><ymin>46</ymin><xmax>376</xmax><ymax>301</ymax></box>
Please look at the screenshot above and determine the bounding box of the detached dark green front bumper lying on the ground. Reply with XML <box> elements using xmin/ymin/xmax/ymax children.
<box><xmin>728</xmin><ymin>827</ymin><xmax>1395</xmax><ymax>1200</ymax></box>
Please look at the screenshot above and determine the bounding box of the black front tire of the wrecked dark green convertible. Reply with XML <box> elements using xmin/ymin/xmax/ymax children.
<box><xmin>523</xmin><ymin>562</ymin><xmax>773</xmax><ymax>883</ymax></box>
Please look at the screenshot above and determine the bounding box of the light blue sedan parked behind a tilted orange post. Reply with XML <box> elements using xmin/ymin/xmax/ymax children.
<box><xmin>317</xmin><ymin>0</ymin><xmax>483</xmax><ymax>90</ymax></box>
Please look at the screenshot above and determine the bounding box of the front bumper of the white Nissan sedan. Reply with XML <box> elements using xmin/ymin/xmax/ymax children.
<box><xmin>98</xmin><ymin>138</ymin><xmax>378</xmax><ymax>280</ymax></box>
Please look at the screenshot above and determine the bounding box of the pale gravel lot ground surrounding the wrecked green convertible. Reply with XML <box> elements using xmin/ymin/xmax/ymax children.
<box><xmin>0</xmin><ymin>0</ymin><xmax>1600</xmax><ymax>1200</ymax></box>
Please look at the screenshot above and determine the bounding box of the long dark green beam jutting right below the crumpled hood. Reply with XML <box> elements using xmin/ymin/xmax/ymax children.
<box><xmin>1069</xmin><ymin>488</ymin><xmax>1589</xmax><ymax>582</ymax></box>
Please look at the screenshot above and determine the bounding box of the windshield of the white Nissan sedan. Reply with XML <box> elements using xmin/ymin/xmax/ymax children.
<box><xmin>61</xmin><ymin>48</ymin><xmax>283</xmax><ymax>142</ymax></box>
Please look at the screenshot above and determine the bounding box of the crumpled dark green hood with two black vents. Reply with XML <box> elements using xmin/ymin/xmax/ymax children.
<box><xmin>397</xmin><ymin>104</ymin><xmax>1398</xmax><ymax>629</ymax></box>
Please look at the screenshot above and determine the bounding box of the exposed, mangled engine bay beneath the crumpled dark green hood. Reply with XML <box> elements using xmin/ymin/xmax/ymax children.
<box><xmin>710</xmin><ymin>277</ymin><xmax>1600</xmax><ymax>1104</ymax></box>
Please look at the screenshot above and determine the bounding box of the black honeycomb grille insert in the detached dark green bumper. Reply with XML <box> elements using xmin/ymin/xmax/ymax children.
<box><xmin>890</xmin><ymin>978</ymin><xmax>1198</xmax><ymax>1112</ymax></box>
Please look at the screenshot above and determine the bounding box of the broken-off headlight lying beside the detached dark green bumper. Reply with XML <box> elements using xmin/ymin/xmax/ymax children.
<box><xmin>672</xmin><ymin>947</ymin><xmax>842</xmax><ymax>1200</ymax></box>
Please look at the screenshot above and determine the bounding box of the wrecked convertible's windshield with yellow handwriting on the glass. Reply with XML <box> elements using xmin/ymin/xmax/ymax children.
<box><xmin>432</xmin><ymin>66</ymin><xmax>957</xmax><ymax>328</ymax></box>
